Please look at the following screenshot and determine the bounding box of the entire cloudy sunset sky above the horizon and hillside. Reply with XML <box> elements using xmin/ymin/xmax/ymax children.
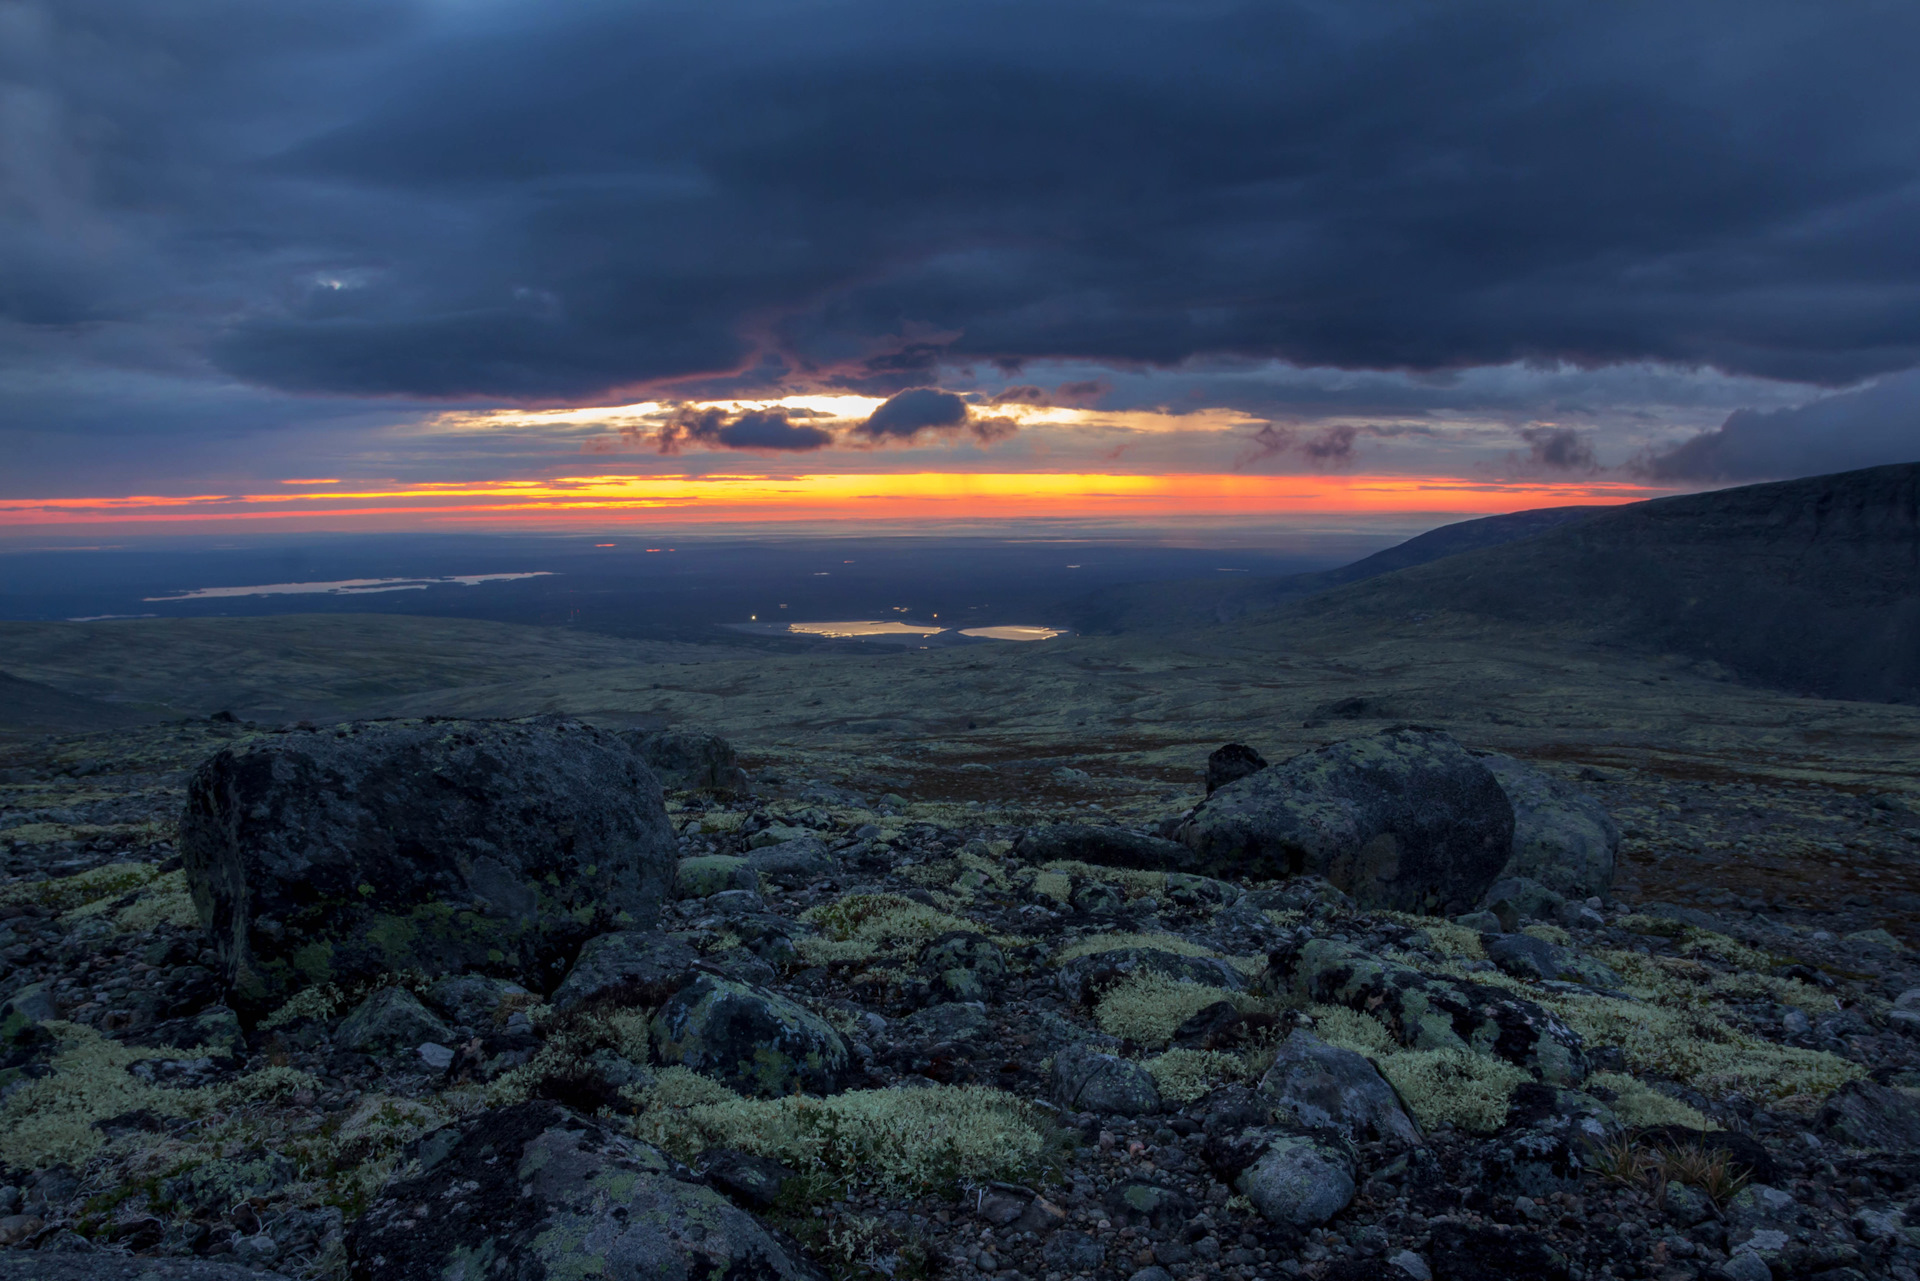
<box><xmin>0</xmin><ymin>0</ymin><xmax>1920</xmax><ymax>534</ymax></box>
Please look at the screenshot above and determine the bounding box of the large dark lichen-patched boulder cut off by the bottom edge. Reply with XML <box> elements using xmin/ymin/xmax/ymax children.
<box><xmin>348</xmin><ymin>1100</ymin><xmax>822</xmax><ymax>1281</ymax></box>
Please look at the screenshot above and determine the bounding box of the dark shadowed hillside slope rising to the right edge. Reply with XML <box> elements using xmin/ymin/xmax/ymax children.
<box><xmin>1258</xmin><ymin>463</ymin><xmax>1920</xmax><ymax>703</ymax></box>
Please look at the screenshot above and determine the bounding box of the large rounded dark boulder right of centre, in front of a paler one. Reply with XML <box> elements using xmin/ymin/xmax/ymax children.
<box><xmin>1179</xmin><ymin>728</ymin><xmax>1513</xmax><ymax>914</ymax></box>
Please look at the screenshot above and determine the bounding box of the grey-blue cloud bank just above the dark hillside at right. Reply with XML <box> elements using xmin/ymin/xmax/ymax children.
<box><xmin>1634</xmin><ymin>371</ymin><xmax>1920</xmax><ymax>480</ymax></box>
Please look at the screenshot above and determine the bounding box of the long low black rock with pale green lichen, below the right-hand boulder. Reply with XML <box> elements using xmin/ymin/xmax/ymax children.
<box><xmin>1265</xmin><ymin>939</ymin><xmax>1588</xmax><ymax>1085</ymax></box>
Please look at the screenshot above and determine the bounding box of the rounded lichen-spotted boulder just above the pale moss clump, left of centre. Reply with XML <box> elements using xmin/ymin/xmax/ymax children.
<box><xmin>649</xmin><ymin>974</ymin><xmax>847</xmax><ymax>1095</ymax></box>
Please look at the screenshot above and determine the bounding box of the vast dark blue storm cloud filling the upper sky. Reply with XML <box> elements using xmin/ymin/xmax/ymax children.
<box><xmin>11</xmin><ymin>0</ymin><xmax>1920</xmax><ymax>416</ymax></box>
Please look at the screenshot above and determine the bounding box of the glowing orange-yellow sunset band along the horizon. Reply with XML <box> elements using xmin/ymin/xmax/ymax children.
<box><xmin>0</xmin><ymin>472</ymin><xmax>1665</xmax><ymax>528</ymax></box>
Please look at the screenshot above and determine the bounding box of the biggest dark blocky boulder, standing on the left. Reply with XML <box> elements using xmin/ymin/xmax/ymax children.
<box><xmin>180</xmin><ymin>720</ymin><xmax>676</xmax><ymax>1012</ymax></box>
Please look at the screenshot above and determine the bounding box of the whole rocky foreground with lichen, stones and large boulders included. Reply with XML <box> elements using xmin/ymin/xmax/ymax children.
<box><xmin>0</xmin><ymin>720</ymin><xmax>1920</xmax><ymax>1281</ymax></box>
